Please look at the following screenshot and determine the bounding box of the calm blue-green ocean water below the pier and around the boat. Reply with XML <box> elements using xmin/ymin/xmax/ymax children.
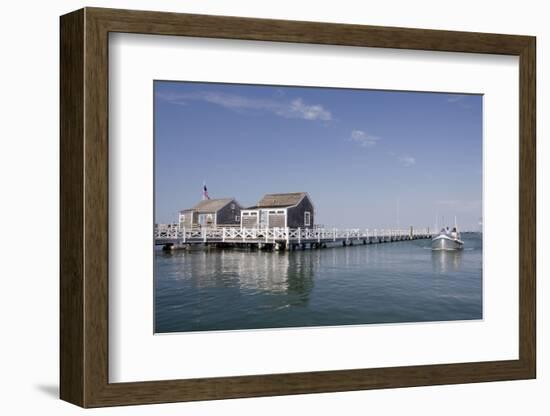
<box><xmin>155</xmin><ymin>234</ymin><xmax>482</xmax><ymax>333</ymax></box>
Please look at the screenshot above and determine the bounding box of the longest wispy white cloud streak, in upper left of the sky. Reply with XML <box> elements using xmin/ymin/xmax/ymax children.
<box><xmin>157</xmin><ymin>91</ymin><xmax>332</xmax><ymax>121</ymax></box>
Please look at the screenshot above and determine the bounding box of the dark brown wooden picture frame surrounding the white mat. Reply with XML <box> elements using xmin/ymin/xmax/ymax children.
<box><xmin>60</xmin><ymin>8</ymin><xmax>536</xmax><ymax>407</ymax></box>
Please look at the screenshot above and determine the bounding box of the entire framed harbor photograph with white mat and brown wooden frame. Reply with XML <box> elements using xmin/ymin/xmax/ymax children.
<box><xmin>60</xmin><ymin>8</ymin><xmax>536</xmax><ymax>407</ymax></box>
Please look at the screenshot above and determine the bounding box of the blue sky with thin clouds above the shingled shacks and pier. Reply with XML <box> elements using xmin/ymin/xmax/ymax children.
<box><xmin>154</xmin><ymin>81</ymin><xmax>482</xmax><ymax>229</ymax></box>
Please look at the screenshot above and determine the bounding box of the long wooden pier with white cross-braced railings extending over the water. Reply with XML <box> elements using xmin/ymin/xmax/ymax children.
<box><xmin>155</xmin><ymin>224</ymin><xmax>432</xmax><ymax>250</ymax></box>
